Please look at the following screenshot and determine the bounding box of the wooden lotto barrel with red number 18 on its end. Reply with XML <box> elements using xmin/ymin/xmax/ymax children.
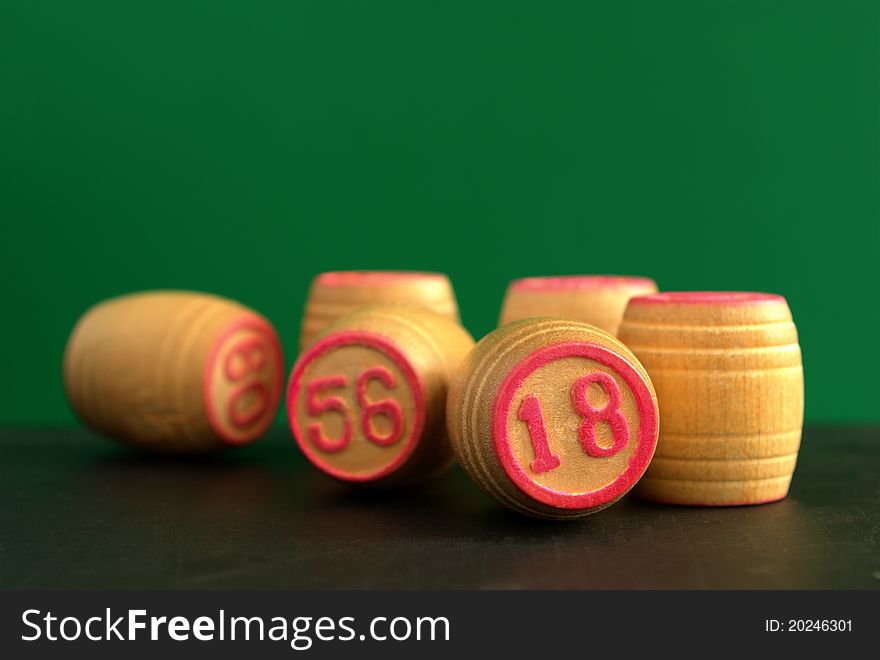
<box><xmin>447</xmin><ymin>318</ymin><xmax>659</xmax><ymax>519</ymax></box>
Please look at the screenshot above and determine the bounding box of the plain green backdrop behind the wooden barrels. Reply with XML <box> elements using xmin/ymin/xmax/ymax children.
<box><xmin>0</xmin><ymin>0</ymin><xmax>880</xmax><ymax>424</ymax></box>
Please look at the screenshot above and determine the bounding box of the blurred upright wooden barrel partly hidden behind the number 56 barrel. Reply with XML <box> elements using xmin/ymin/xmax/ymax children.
<box><xmin>299</xmin><ymin>271</ymin><xmax>459</xmax><ymax>350</ymax></box>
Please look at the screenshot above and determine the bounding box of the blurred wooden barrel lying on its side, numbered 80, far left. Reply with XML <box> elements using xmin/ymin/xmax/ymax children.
<box><xmin>63</xmin><ymin>291</ymin><xmax>284</xmax><ymax>452</ymax></box>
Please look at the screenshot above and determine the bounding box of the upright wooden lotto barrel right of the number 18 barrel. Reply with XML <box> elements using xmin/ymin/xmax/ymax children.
<box><xmin>620</xmin><ymin>292</ymin><xmax>804</xmax><ymax>506</ymax></box>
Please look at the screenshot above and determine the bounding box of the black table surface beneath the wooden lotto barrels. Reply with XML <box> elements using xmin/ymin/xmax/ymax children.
<box><xmin>0</xmin><ymin>426</ymin><xmax>880</xmax><ymax>589</ymax></box>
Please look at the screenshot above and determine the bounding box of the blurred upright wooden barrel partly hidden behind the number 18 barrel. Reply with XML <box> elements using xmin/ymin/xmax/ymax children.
<box><xmin>499</xmin><ymin>275</ymin><xmax>657</xmax><ymax>335</ymax></box>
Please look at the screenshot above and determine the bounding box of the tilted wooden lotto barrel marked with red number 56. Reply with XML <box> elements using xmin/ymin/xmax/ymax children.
<box><xmin>287</xmin><ymin>305</ymin><xmax>474</xmax><ymax>486</ymax></box>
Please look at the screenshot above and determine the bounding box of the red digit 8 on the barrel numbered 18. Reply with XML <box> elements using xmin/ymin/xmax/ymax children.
<box><xmin>571</xmin><ymin>371</ymin><xmax>629</xmax><ymax>458</ymax></box>
